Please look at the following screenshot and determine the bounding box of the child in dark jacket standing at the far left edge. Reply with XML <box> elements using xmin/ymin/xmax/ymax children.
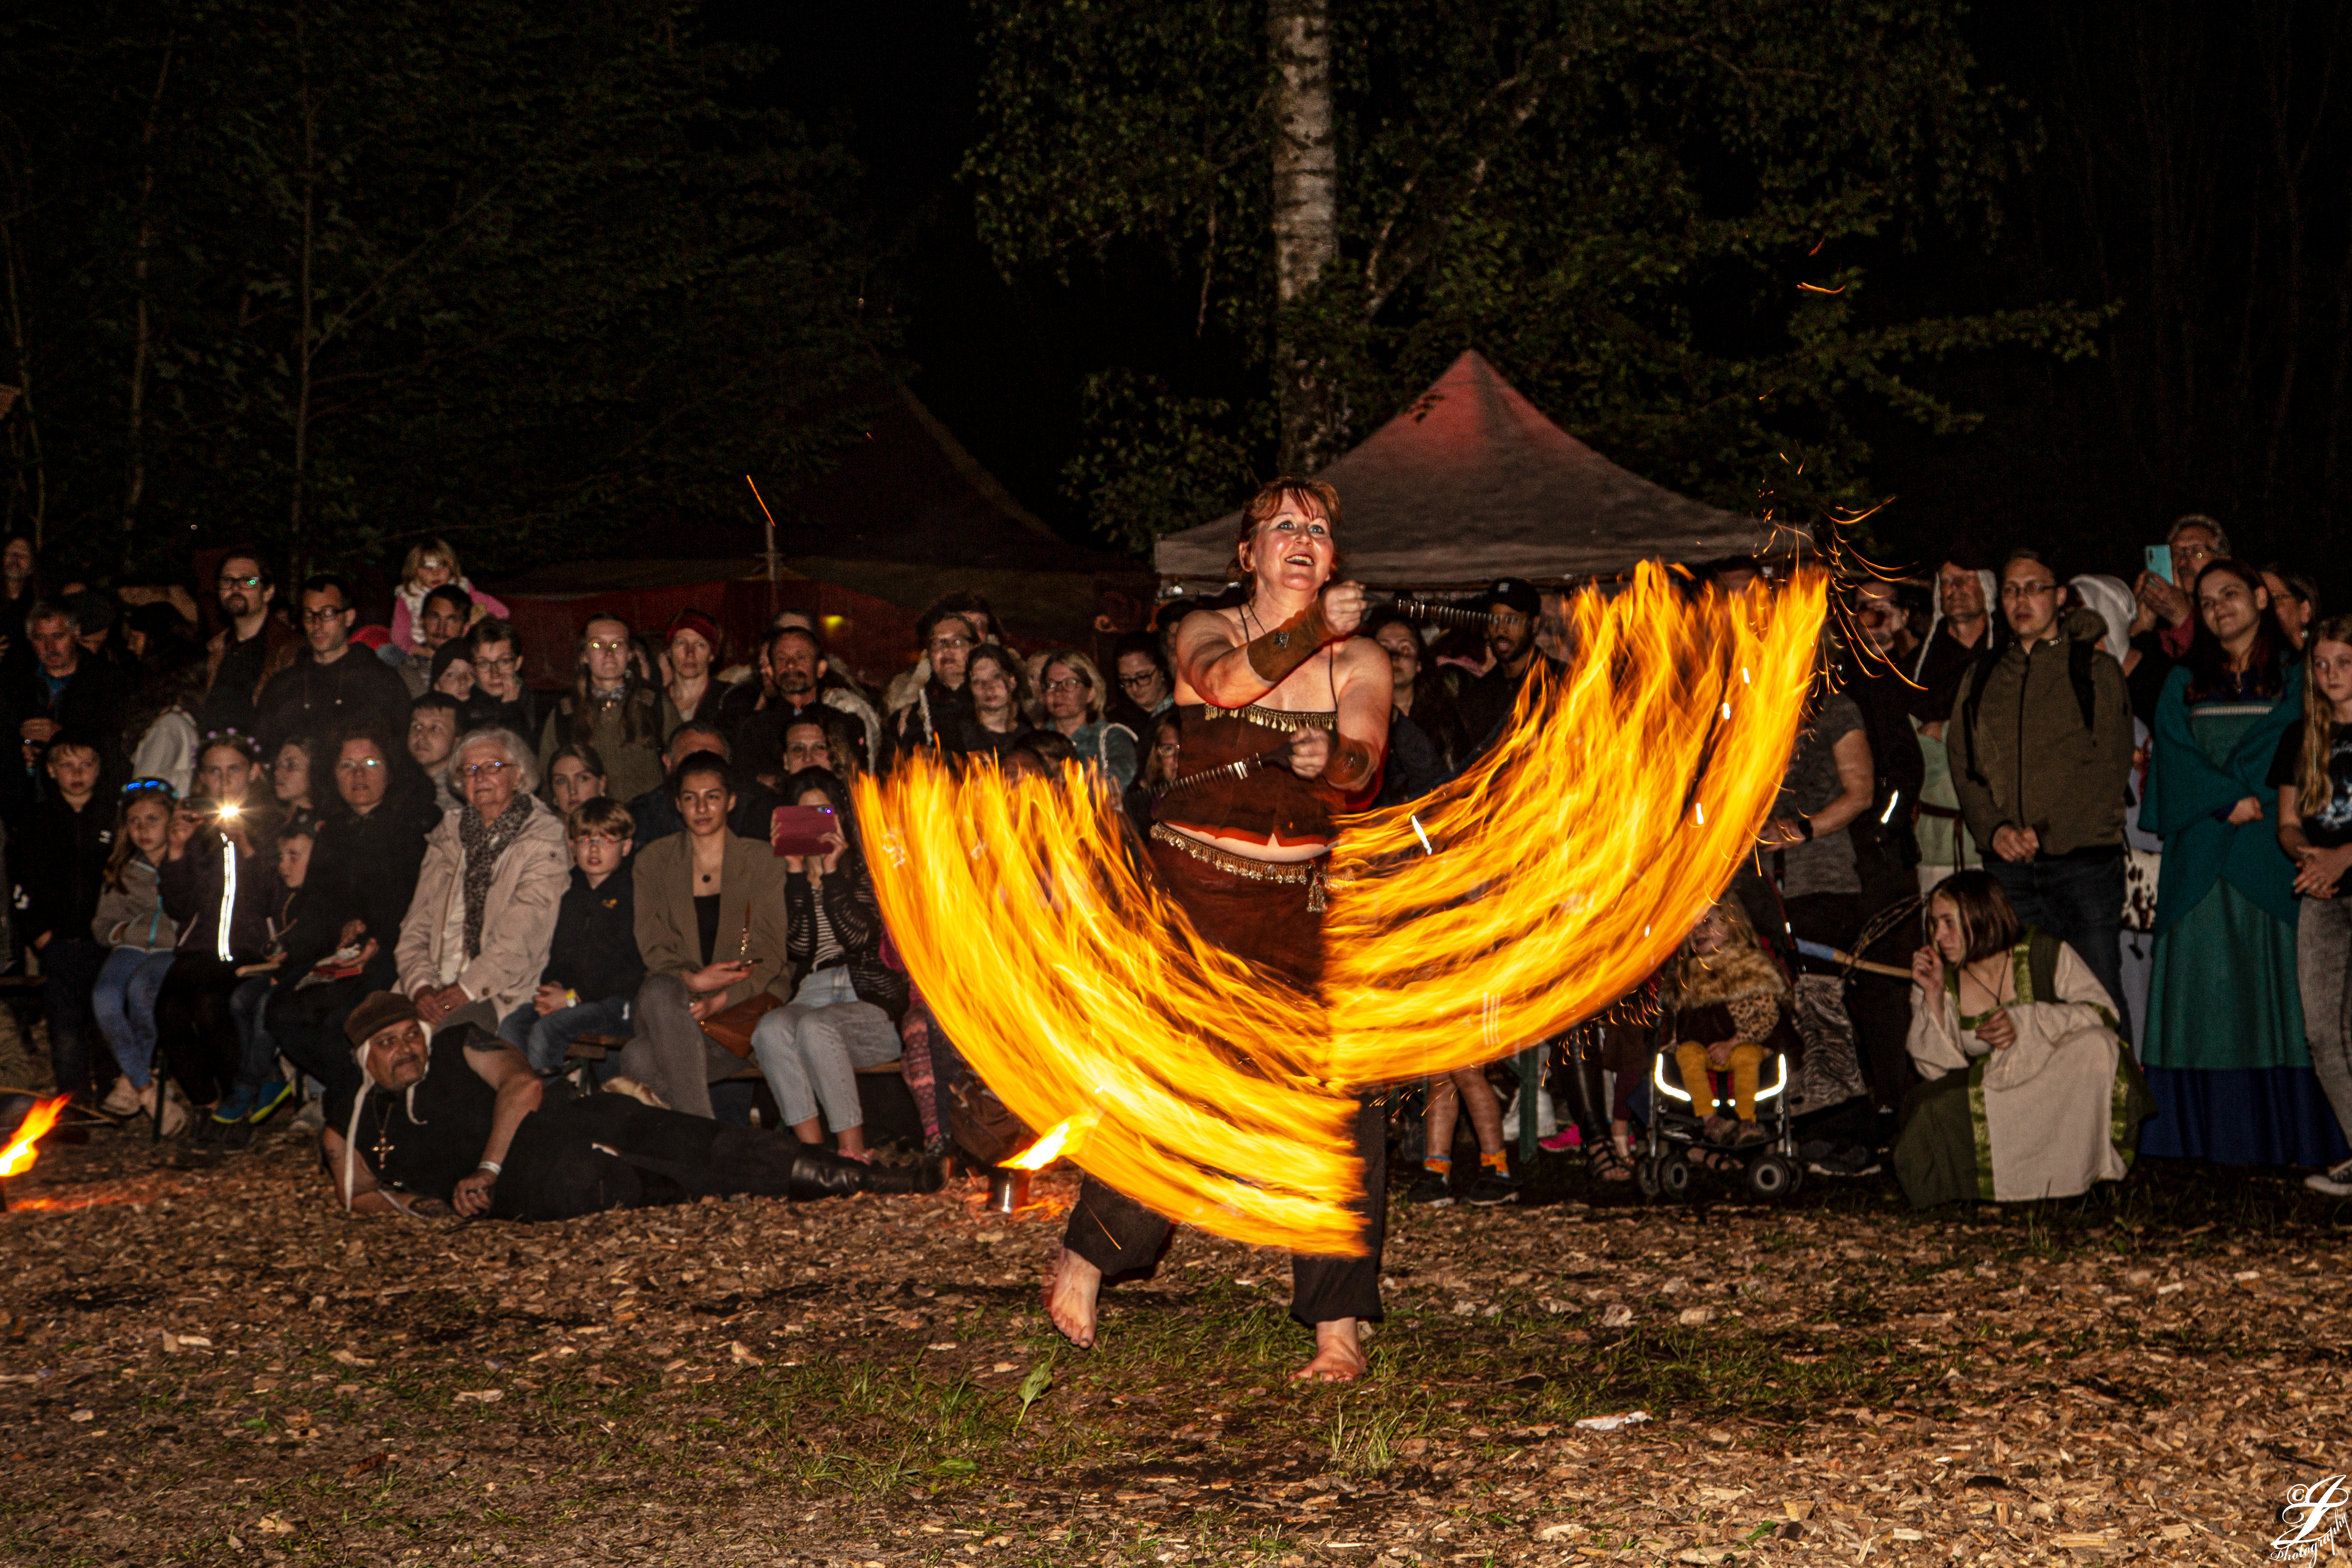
<box><xmin>9</xmin><ymin>738</ymin><xmax>115</xmax><ymax>1095</ymax></box>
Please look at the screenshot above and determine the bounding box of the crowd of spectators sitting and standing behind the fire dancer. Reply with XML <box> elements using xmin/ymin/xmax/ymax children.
<box><xmin>0</xmin><ymin>517</ymin><xmax>2352</xmax><ymax>1213</ymax></box>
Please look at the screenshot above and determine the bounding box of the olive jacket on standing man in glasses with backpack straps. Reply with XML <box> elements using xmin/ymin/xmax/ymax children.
<box><xmin>1943</xmin><ymin>609</ymin><xmax>2131</xmax><ymax>861</ymax></box>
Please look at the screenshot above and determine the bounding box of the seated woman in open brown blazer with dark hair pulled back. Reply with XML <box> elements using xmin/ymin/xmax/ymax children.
<box><xmin>619</xmin><ymin>752</ymin><xmax>792</xmax><ymax>1117</ymax></box>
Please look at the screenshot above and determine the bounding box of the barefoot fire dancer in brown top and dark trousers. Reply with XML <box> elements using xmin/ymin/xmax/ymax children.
<box><xmin>1047</xmin><ymin>480</ymin><xmax>1390</xmax><ymax>1380</ymax></box>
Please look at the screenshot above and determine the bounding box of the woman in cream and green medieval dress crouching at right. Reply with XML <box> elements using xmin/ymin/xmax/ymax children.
<box><xmin>1896</xmin><ymin>872</ymin><xmax>2154</xmax><ymax>1208</ymax></box>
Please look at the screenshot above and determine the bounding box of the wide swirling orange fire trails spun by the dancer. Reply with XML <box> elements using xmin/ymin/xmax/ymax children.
<box><xmin>858</xmin><ymin>567</ymin><xmax>1828</xmax><ymax>1253</ymax></box>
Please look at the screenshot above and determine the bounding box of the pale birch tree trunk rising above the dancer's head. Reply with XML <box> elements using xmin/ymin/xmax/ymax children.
<box><xmin>1265</xmin><ymin>0</ymin><xmax>1338</xmax><ymax>475</ymax></box>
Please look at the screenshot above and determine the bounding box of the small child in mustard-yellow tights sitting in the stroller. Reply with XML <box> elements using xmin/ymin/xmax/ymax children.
<box><xmin>1658</xmin><ymin>898</ymin><xmax>1802</xmax><ymax>1152</ymax></box>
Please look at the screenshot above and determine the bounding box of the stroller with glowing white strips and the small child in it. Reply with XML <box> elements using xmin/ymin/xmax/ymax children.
<box><xmin>1635</xmin><ymin>898</ymin><xmax>1802</xmax><ymax>1199</ymax></box>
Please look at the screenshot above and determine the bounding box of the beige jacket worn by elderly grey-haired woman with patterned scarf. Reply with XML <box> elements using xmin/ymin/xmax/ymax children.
<box><xmin>393</xmin><ymin>799</ymin><xmax>572</xmax><ymax>1018</ymax></box>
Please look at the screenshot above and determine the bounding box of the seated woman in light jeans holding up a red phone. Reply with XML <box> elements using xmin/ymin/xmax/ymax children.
<box><xmin>750</xmin><ymin>769</ymin><xmax>908</xmax><ymax>1159</ymax></box>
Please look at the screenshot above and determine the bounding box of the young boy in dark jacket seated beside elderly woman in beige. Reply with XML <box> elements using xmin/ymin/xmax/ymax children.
<box><xmin>499</xmin><ymin>795</ymin><xmax>645</xmax><ymax>1074</ymax></box>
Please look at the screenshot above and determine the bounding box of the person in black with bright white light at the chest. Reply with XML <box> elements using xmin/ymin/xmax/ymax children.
<box><xmin>155</xmin><ymin>785</ymin><xmax>287</xmax><ymax>1114</ymax></box>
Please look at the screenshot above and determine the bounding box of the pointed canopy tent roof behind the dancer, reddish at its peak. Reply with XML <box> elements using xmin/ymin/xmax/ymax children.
<box><xmin>1157</xmin><ymin>350</ymin><xmax>1787</xmax><ymax>588</ymax></box>
